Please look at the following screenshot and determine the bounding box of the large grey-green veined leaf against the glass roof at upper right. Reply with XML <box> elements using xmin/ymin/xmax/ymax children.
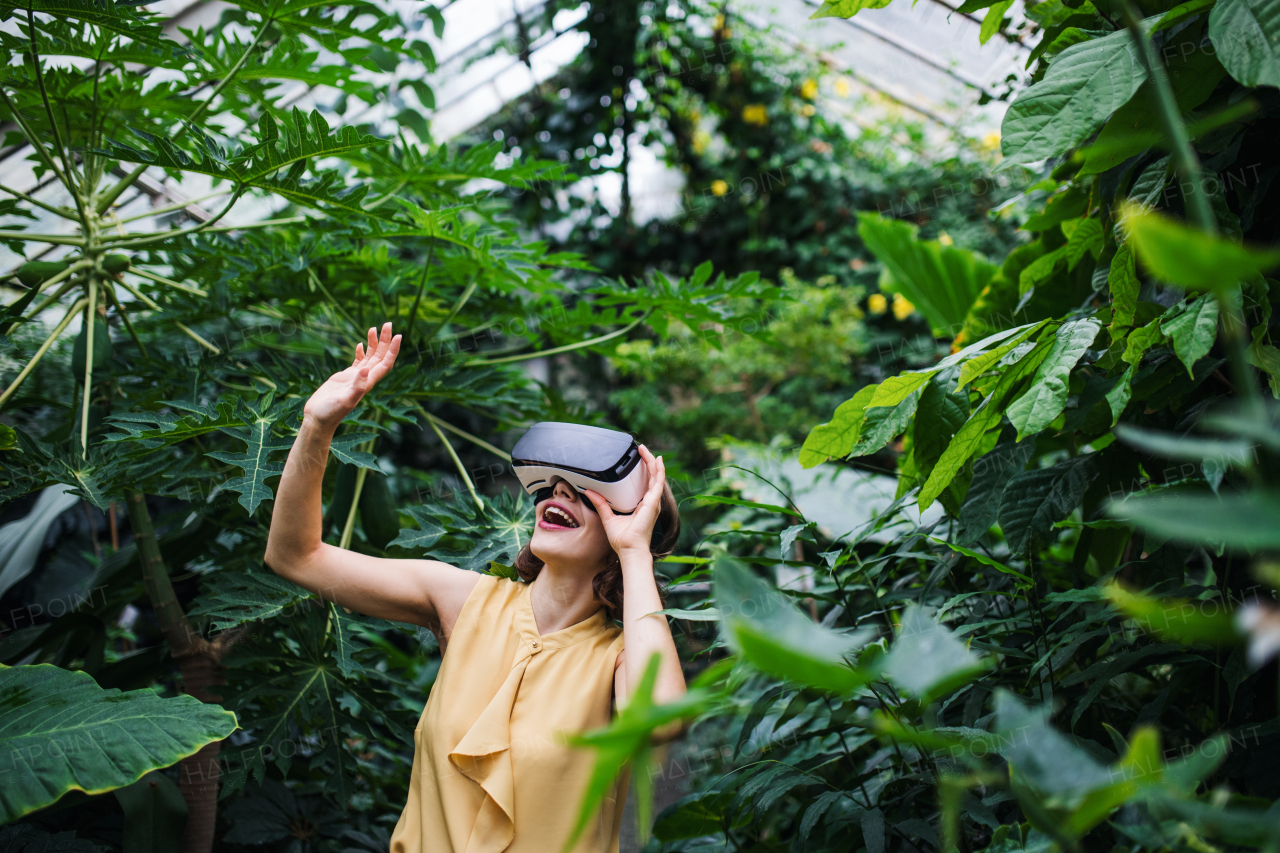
<box><xmin>1000</xmin><ymin>25</ymin><xmax>1156</xmax><ymax>168</ymax></box>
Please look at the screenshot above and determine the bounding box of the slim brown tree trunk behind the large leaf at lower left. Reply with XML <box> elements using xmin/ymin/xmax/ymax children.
<box><xmin>128</xmin><ymin>491</ymin><xmax>243</xmax><ymax>853</ymax></box>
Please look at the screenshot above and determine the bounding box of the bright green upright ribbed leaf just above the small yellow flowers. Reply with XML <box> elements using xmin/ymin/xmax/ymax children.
<box><xmin>858</xmin><ymin>211</ymin><xmax>996</xmax><ymax>337</ymax></box>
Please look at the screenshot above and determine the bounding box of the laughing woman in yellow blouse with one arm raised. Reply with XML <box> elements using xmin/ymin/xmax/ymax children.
<box><xmin>264</xmin><ymin>323</ymin><xmax>685</xmax><ymax>853</ymax></box>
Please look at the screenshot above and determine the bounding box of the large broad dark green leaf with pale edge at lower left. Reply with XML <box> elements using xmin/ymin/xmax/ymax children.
<box><xmin>0</xmin><ymin>663</ymin><xmax>236</xmax><ymax>822</ymax></box>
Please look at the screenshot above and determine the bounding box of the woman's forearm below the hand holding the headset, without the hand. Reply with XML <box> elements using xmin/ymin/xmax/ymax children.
<box><xmin>620</xmin><ymin>551</ymin><xmax>686</xmax><ymax>703</ymax></box>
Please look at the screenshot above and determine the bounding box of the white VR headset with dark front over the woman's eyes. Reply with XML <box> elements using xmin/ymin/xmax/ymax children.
<box><xmin>511</xmin><ymin>420</ymin><xmax>649</xmax><ymax>515</ymax></box>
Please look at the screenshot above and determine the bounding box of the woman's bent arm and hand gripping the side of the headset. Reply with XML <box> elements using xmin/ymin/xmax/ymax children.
<box><xmin>585</xmin><ymin>444</ymin><xmax>686</xmax><ymax>740</ymax></box>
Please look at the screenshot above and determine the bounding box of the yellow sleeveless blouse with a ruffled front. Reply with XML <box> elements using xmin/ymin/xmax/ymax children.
<box><xmin>390</xmin><ymin>575</ymin><xmax>628</xmax><ymax>853</ymax></box>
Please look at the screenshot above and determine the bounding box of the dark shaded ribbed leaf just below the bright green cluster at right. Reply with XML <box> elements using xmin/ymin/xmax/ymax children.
<box><xmin>1000</xmin><ymin>453</ymin><xmax>1098</xmax><ymax>555</ymax></box>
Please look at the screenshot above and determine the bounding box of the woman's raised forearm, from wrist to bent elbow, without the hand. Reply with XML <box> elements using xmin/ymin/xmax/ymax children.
<box><xmin>264</xmin><ymin>415</ymin><xmax>335</xmax><ymax>575</ymax></box>
